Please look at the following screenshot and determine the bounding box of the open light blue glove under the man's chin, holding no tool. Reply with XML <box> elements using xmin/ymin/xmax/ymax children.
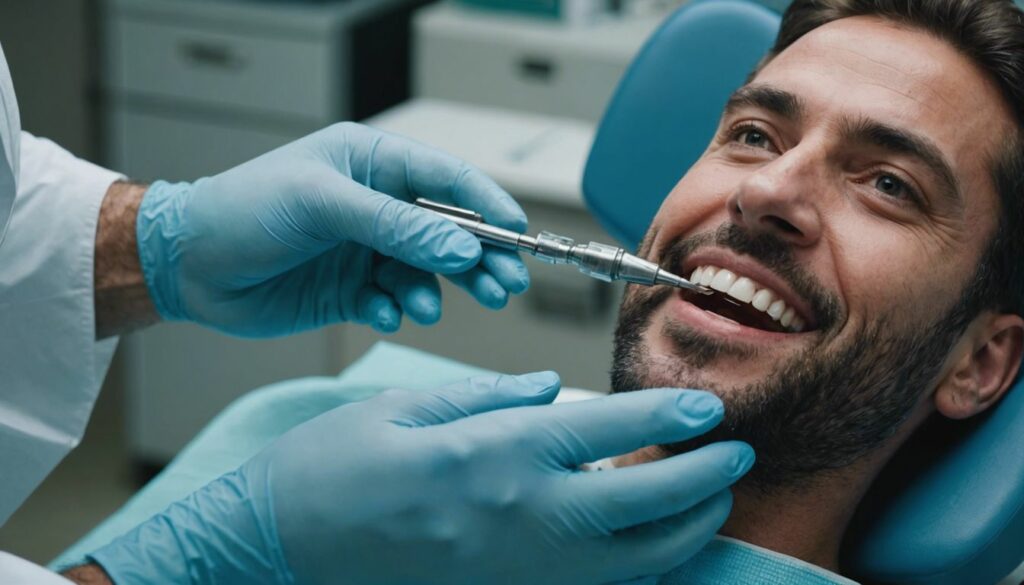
<box><xmin>90</xmin><ymin>373</ymin><xmax>753</xmax><ymax>585</ymax></box>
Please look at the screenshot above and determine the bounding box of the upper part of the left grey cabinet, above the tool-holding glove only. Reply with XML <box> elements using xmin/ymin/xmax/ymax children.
<box><xmin>100</xmin><ymin>0</ymin><xmax>427</xmax><ymax>179</ymax></box>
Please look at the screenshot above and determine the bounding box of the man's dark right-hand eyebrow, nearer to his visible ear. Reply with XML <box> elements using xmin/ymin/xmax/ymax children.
<box><xmin>843</xmin><ymin>118</ymin><xmax>964</xmax><ymax>206</ymax></box>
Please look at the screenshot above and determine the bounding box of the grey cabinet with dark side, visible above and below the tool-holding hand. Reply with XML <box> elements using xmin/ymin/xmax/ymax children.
<box><xmin>105</xmin><ymin>0</ymin><xmax>429</xmax><ymax>465</ymax></box>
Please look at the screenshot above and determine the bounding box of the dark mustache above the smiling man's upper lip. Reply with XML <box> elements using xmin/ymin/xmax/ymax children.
<box><xmin>658</xmin><ymin>223</ymin><xmax>842</xmax><ymax>331</ymax></box>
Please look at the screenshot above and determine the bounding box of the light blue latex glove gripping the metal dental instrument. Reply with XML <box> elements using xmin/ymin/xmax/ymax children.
<box><xmin>137</xmin><ymin>123</ymin><xmax>529</xmax><ymax>337</ymax></box>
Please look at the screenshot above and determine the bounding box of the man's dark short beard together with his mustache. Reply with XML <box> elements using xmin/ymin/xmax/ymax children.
<box><xmin>611</xmin><ymin>224</ymin><xmax>972</xmax><ymax>493</ymax></box>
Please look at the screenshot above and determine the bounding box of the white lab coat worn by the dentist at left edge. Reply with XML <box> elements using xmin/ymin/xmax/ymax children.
<box><xmin>0</xmin><ymin>44</ymin><xmax>119</xmax><ymax>585</ymax></box>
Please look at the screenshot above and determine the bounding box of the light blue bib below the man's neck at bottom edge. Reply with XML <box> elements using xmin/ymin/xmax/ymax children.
<box><xmin>658</xmin><ymin>537</ymin><xmax>855</xmax><ymax>585</ymax></box>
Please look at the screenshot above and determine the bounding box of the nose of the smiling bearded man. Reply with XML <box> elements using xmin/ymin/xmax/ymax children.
<box><xmin>728</xmin><ymin>151</ymin><xmax>825</xmax><ymax>246</ymax></box>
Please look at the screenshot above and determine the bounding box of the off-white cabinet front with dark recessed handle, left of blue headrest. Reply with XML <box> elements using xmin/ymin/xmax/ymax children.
<box><xmin>413</xmin><ymin>2</ymin><xmax>663</xmax><ymax>125</ymax></box>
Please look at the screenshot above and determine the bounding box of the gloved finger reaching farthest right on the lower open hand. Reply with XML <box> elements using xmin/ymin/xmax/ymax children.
<box><xmin>568</xmin><ymin>441</ymin><xmax>754</xmax><ymax>531</ymax></box>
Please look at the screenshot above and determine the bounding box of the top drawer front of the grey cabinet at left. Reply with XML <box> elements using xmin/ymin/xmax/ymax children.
<box><xmin>106</xmin><ymin>16</ymin><xmax>338</xmax><ymax>121</ymax></box>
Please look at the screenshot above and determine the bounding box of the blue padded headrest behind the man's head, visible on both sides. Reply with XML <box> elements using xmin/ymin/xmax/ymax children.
<box><xmin>583</xmin><ymin>0</ymin><xmax>1024</xmax><ymax>585</ymax></box>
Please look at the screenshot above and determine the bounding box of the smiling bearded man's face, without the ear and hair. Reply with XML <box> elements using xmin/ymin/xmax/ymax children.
<box><xmin>613</xmin><ymin>17</ymin><xmax>1015</xmax><ymax>487</ymax></box>
